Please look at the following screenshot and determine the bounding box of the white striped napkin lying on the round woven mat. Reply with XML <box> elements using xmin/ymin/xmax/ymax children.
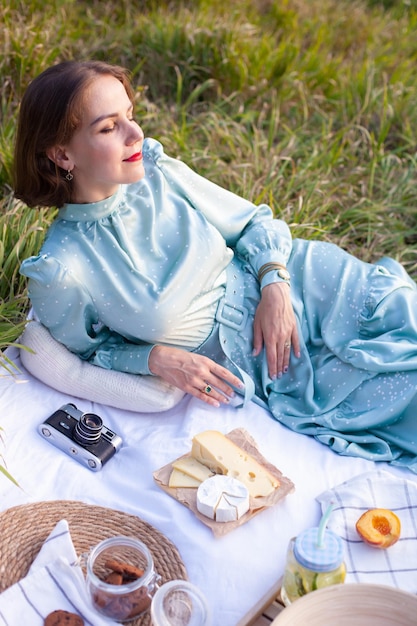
<box><xmin>0</xmin><ymin>520</ymin><xmax>116</xmax><ymax>626</ymax></box>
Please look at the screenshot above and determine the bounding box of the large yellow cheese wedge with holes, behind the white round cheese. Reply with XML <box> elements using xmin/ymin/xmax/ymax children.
<box><xmin>191</xmin><ymin>430</ymin><xmax>280</xmax><ymax>498</ymax></box>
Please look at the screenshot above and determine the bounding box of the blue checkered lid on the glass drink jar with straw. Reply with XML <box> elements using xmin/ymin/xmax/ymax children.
<box><xmin>294</xmin><ymin>527</ymin><xmax>343</xmax><ymax>572</ymax></box>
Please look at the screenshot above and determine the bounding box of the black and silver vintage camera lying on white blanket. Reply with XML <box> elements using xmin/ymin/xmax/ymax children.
<box><xmin>38</xmin><ymin>404</ymin><xmax>122</xmax><ymax>472</ymax></box>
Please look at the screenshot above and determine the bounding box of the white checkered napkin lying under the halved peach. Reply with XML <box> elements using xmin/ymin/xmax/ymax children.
<box><xmin>317</xmin><ymin>471</ymin><xmax>417</xmax><ymax>593</ymax></box>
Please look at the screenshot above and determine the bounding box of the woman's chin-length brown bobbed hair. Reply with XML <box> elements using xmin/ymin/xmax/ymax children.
<box><xmin>14</xmin><ymin>61</ymin><xmax>134</xmax><ymax>207</ymax></box>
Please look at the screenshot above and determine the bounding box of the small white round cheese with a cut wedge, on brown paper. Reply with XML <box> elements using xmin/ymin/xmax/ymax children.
<box><xmin>197</xmin><ymin>474</ymin><xmax>249</xmax><ymax>522</ymax></box>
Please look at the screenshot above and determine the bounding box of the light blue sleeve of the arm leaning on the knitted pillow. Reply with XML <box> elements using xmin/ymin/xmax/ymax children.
<box><xmin>20</xmin><ymin>255</ymin><xmax>153</xmax><ymax>374</ymax></box>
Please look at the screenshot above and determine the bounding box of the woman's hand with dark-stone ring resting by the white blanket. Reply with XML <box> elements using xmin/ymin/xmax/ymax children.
<box><xmin>149</xmin><ymin>346</ymin><xmax>243</xmax><ymax>407</ymax></box>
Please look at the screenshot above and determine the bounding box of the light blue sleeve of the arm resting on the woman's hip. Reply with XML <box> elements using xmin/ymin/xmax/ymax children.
<box><xmin>148</xmin><ymin>140</ymin><xmax>292</xmax><ymax>286</ymax></box>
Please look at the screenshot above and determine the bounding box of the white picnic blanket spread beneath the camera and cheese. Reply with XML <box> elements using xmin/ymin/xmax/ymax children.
<box><xmin>0</xmin><ymin>349</ymin><xmax>417</xmax><ymax>626</ymax></box>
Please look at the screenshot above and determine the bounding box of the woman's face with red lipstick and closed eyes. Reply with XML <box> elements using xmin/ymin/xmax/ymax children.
<box><xmin>63</xmin><ymin>75</ymin><xmax>145</xmax><ymax>203</ymax></box>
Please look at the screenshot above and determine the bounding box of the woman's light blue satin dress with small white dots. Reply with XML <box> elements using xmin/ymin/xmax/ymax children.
<box><xmin>21</xmin><ymin>139</ymin><xmax>417</xmax><ymax>471</ymax></box>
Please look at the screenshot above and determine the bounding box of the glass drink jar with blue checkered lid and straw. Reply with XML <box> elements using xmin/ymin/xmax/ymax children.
<box><xmin>281</xmin><ymin>527</ymin><xmax>346</xmax><ymax>606</ymax></box>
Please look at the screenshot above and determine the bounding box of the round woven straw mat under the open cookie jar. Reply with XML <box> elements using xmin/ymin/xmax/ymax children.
<box><xmin>0</xmin><ymin>500</ymin><xmax>187</xmax><ymax>626</ymax></box>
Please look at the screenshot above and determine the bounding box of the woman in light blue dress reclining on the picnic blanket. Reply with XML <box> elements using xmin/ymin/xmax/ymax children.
<box><xmin>15</xmin><ymin>62</ymin><xmax>417</xmax><ymax>463</ymax></box>
